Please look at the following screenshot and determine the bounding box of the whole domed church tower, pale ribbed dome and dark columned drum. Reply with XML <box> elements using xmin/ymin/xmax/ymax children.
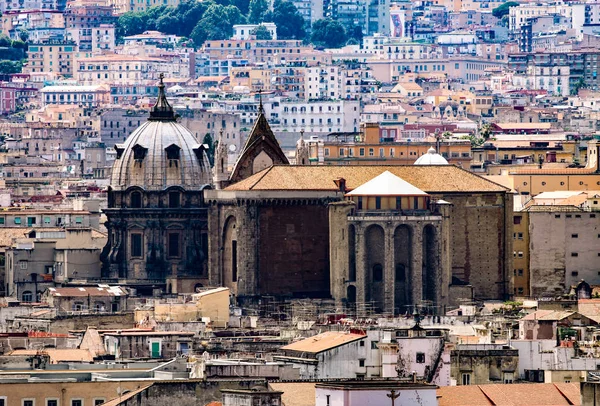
<box><xmin>102</xmin><ymin>76</ymin><xmax>212</xmax><ymax>294</ymax></box>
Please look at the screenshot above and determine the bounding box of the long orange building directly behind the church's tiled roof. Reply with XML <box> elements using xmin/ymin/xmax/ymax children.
<box><xmin>316</xmin><ymin>123</ymin><xmax>471</xmax><ymax>169</ymax></box>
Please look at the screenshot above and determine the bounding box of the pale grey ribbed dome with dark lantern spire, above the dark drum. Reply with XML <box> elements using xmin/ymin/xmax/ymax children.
<box><xmin>110</xmin><ymin>78</ymin><xmax>211</xmax><ymax>191</ymax></box>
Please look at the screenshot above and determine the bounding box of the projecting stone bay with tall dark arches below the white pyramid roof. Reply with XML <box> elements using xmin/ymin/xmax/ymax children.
<box><xmin>329</xmin><ymin>202</ymin><xmax>451</xmax><ymax>314</ymax></box>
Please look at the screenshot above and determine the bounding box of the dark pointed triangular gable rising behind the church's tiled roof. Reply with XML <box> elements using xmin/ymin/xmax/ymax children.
<box><xmin>229</xmin><ymin>102</ymin><xmax>289</xmax><ymax>183</ymax></box>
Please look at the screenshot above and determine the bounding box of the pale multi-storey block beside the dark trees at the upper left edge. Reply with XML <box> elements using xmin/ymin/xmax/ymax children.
<box><xmin>23</xmin><ymin>41</ymin><xmax>77</xmax><ymax>77</ymax></box>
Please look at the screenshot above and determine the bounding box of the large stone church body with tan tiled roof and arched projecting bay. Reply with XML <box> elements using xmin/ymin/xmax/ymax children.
<box><xmin>205</xmin><ymin>132</ymin><xmax>512</xmax><ymax>314</ymax></box>
